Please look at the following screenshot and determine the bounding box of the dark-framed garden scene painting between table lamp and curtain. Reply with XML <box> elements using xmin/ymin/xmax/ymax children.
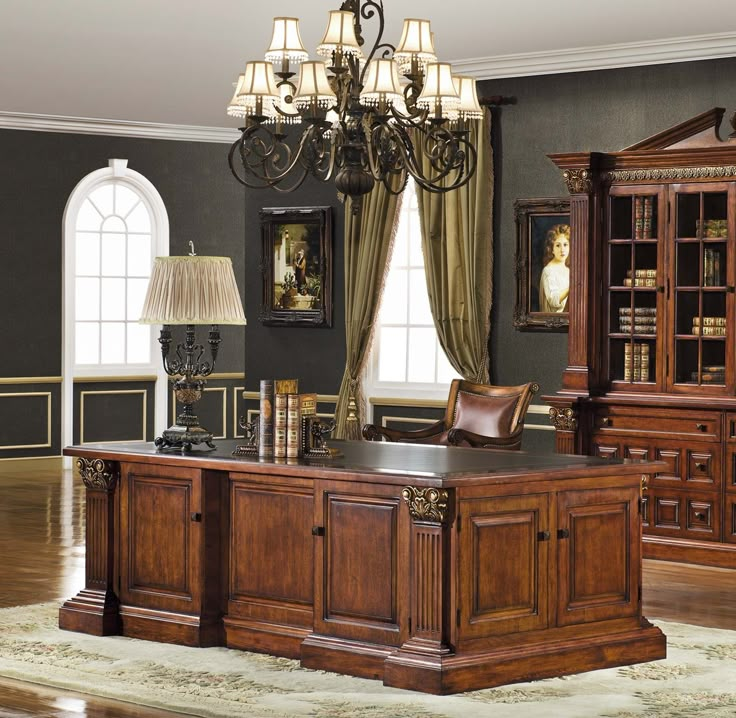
<box><xmin>260</xmin><ymin>207</ymin><xmax>332</xmax><ymax>327</ymax></box>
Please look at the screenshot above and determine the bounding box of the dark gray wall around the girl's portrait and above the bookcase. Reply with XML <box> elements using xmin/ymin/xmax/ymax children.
<box><xmin>479</xmin><ymin>58</ymin><xmax>736</xmax><ymax>394</ymax></box>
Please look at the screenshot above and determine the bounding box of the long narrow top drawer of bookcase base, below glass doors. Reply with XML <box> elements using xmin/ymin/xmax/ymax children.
<box><xmin>594</xmin><ymin>406</ymin><xmax>721</xmax><ymax>441</ymax></box>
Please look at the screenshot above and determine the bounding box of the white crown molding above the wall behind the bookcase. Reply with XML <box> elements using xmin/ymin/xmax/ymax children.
<box><xmin>452</xmin><ymin>32</ymin><xmax>736</xmax><ymax>80</ymax></box>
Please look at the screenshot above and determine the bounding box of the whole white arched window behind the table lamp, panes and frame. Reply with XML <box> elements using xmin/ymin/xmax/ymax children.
<box><xmin>62</xmin><ymin>159</ymin><xmax>169</xmax><ymax>444</ymax></box>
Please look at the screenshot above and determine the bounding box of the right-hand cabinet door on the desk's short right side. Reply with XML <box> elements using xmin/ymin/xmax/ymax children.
<box><xmin>557</xmin><ymin>488</ymin><xmax>641</xmax><ymax>626</ymax></box>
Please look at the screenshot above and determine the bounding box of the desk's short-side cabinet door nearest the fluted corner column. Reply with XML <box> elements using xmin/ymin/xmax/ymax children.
<box><xmin>459</xmin><ymin>494</ymin><xmax>551</xmax><ymax>638</ymax></box>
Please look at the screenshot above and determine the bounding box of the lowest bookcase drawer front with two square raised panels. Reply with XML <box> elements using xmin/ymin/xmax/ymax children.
<box><xmin>644</xmin><ymin>489</ymin><xmax>721</xmax><ymax>541</ymax></box>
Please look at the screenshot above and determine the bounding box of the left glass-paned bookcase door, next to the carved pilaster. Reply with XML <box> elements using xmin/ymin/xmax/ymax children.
<box><xmin>606</xmin><ymin>186</ymin><xmax>666</xmax><ymax>391</ymax></box>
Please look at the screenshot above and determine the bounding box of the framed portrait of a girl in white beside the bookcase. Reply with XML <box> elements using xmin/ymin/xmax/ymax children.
<box><xmin>514</xmin><ymin>198</ymin><xmax>571</xmax><ymax>331</ymax></box>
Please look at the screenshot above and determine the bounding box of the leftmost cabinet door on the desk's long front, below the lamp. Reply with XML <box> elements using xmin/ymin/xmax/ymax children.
<box><xmin>120</xmin><ymin>464</ymin><xmax>202</xmax><ymax>613</ymax></box>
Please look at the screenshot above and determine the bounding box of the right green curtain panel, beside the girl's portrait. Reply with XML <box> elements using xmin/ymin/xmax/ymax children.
<box><xmin>417</xmin><ymin>109</ymin><xmax>493</xmax><ymax>384</ymax></box>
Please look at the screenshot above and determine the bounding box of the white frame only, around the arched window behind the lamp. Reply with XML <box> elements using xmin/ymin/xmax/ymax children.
<box><xmin>61</xmin><ymin>159</ymin><xmax>169</xmax><ymax>446</ymax></box>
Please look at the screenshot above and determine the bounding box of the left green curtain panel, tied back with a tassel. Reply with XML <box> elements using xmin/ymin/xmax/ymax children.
<box><xmin>333</xmin><ymin>184</ymin><xmax>401</xmax><ymax>439</ymax></box>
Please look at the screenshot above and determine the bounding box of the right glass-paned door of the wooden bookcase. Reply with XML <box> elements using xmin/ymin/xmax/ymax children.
<box><xmin>667</xmin><ymin>184</ymin><xmax>734</xmax><ymax>393</ymax></box>
